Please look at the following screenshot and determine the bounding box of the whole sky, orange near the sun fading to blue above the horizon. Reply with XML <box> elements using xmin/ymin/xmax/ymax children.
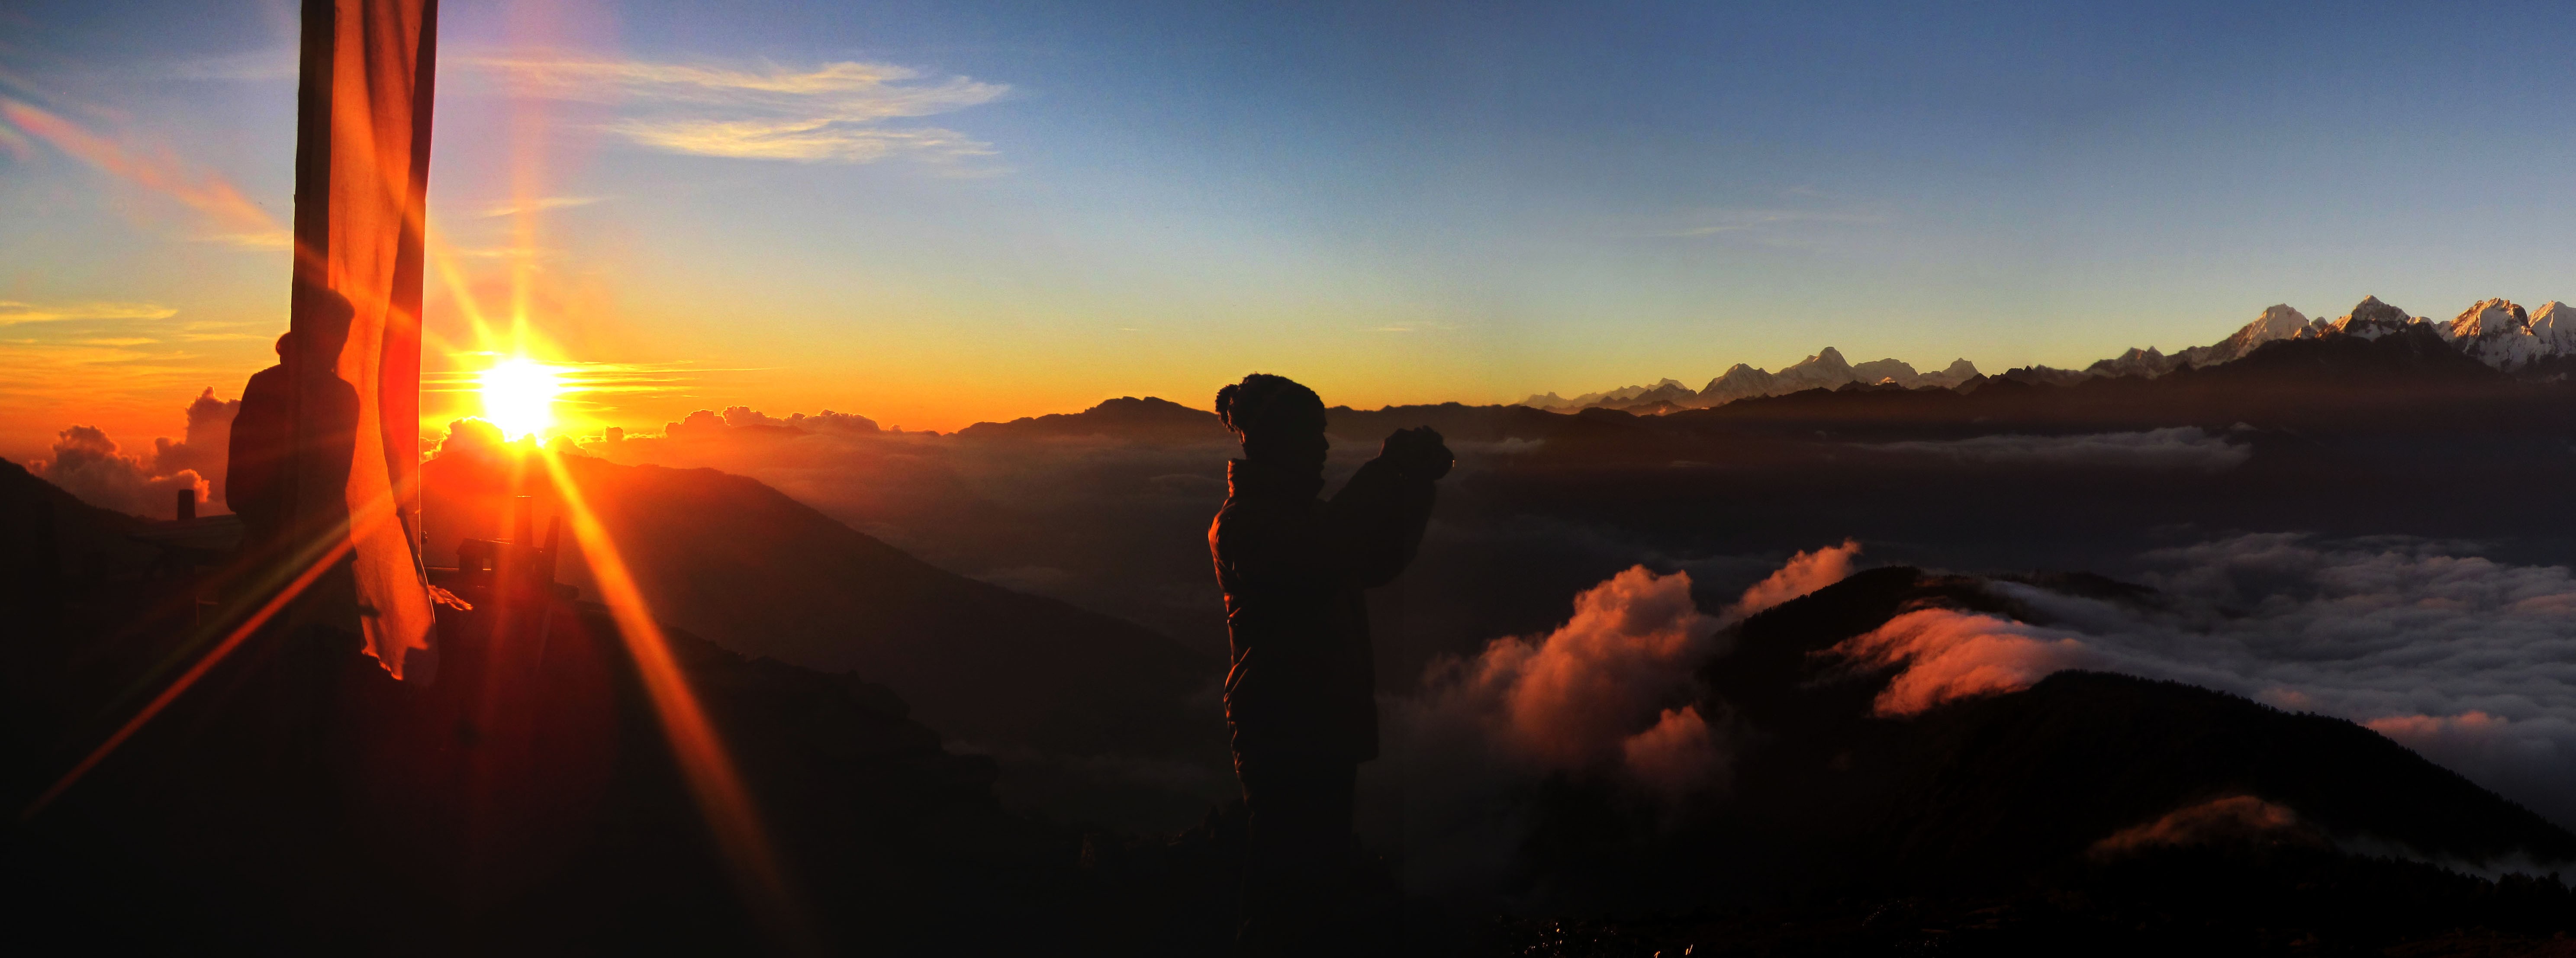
<box><xmin>0</xmin><ymin>0</ymin><xmax>2576</xmax><ymax>461</ymax></box>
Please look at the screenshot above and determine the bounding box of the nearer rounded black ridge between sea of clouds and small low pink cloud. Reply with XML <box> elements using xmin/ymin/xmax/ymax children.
<box><xmin>1886</xmin><ymin>672</ymin><xmax>2576</xmax><ymax>883</ymax></box>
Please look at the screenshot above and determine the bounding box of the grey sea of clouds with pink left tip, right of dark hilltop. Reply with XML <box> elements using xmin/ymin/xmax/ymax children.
<box><xmin>1837</xmin><ymin>533</ymin><xmax>2576</xmax><ymax>827</ymax></box>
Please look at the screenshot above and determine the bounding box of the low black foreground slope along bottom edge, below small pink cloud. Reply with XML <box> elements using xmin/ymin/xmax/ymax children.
<box><xmin>1491</xmin><ymin>847</ymin><xmax>2576</xmax><ymax>958</ymax></box>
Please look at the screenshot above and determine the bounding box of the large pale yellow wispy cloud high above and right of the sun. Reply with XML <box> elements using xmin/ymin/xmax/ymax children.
<box><xmin>464</xmin><ymin>54</ymin><xmax>1010</xmax><ymax>173</ymax></box>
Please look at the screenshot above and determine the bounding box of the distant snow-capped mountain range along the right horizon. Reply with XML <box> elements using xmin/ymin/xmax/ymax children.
<box><xmin>1520</xmin><ymin>296</ymin><xmax>2576</xmax><ymax>412</ymax></box>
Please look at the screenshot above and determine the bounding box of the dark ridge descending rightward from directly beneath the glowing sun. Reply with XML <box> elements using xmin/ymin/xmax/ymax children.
<box><xmin>422</xmin><ymin>448</ymin><xmax>1231</xmax><ymax>827</ymax></box>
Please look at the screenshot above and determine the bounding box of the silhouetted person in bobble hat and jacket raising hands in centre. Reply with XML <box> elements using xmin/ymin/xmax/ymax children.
<box><xmin>1208</xmin><ymin>374</ymin><xmax>1450</xmax><ymax>953</ymax></box>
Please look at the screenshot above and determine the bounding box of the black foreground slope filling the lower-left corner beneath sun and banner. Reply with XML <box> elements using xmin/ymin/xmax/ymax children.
<box><xmin>0</xmin><ymin>466</ymin><xmax>1231</xmax><ymax>955</ymax></box>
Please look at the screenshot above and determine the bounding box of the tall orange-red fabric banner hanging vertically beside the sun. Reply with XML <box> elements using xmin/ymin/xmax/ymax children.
<box><xmin>289</xmin><ymin>0</ymin><xmax>438</xmax><ymax>677</ymax></box>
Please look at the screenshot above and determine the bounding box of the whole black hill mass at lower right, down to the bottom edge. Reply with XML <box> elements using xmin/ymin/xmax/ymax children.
<box><xmin>1510</xmin><ymin>567</ymin><xmax>2576</xmax><ymax>955</ymax></box>
